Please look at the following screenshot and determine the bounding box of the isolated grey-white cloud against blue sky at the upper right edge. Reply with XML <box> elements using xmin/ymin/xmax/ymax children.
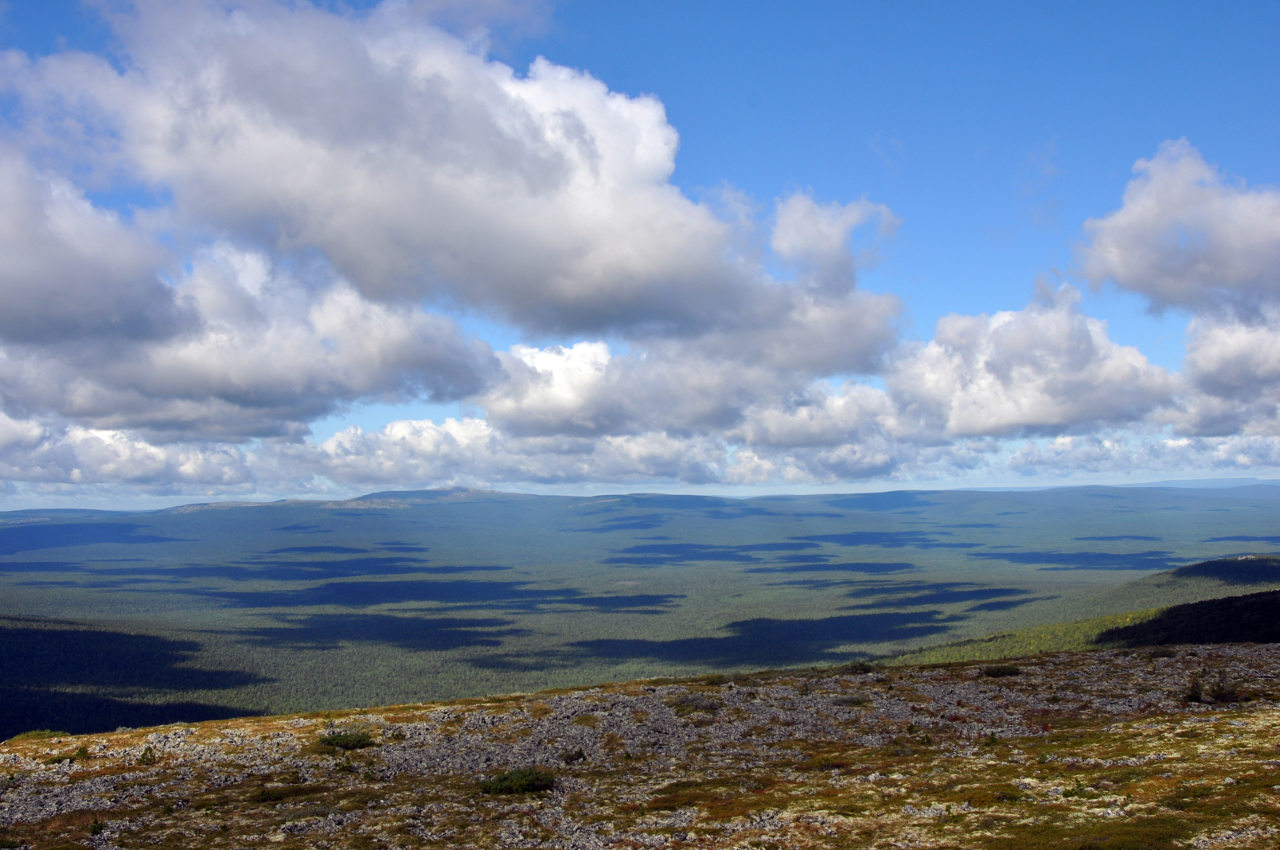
<box><xmin>1080</xmin><ymin>140</ymin><xmax>1280</xmax><ymax>312</ymax></box>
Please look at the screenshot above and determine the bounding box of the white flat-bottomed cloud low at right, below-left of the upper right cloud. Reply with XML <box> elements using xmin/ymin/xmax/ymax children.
<box><xmin>886</xmin><ymin>285</ymin><xmax>1178</xmax><ymax>437</ymax></box>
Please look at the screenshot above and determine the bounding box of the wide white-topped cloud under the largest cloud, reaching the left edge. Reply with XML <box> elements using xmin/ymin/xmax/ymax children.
<box><xmin>0</xmin><ymin>245</ymin><xmax>498</xmax><ymax>442</ymax></box>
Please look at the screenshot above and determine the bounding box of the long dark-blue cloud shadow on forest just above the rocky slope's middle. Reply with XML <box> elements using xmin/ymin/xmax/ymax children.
<box><xmin>470</xmin><ymin>611</ymin><xmax>954</xmax><ymax>671</ymax></box>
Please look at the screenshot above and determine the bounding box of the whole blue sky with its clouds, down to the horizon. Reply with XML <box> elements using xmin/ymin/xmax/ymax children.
<box><xmin>0</xmin><ymin>0</ymin><xmax>1280</xmax><ymax>509</ymax></box>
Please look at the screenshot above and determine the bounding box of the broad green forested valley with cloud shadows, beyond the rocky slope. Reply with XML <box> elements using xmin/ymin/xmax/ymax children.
<box><xmin>0</xmin><ymin>485</ymin><xmax>1280</xmax><ymax>737</ymax></box>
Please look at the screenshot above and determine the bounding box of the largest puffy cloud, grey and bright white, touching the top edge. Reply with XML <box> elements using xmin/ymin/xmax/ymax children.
<box><xmin>7</xmin><ymin>0</ymin><xmax>760</xmax><ymax>332</ymax></box>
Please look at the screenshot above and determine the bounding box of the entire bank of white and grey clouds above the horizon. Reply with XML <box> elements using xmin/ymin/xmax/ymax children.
<box><xmin>0</xmin><ymin>0</ymin><xmax>1280</xmax><ymax>504</ymax></box>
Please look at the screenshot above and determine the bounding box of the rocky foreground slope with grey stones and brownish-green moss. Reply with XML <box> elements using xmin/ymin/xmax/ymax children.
<box><xmin>0</xmin><ymin>645</ymin><xmax>1280</xmax><ymax>850</ymax></box>
